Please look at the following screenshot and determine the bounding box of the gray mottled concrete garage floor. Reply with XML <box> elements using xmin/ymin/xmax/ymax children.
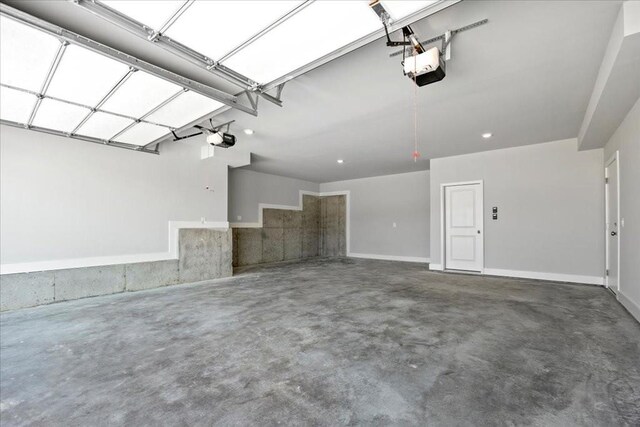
<box><xmin>0</xmin><ymin>259</ymin><xmax>640</xmax><ymax>426</ymax></box>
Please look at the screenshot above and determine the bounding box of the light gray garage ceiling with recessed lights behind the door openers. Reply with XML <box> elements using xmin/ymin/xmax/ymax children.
<box><xmin>7</xmin><ymin>1</ymin><xmax>621</xmax><ymax>182</ymax></box>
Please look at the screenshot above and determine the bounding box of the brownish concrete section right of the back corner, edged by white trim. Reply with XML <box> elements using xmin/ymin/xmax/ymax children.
<box><xmin>319</xmin><ymin>196</ymin><xmax>347</xmax><ymax>256</ymax></box>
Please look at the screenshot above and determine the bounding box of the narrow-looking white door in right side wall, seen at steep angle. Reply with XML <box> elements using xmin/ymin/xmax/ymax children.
<box><xmin>606</xmin><ymin>157</ymin><xmax>620</xmax><ymax>293</ymax></box>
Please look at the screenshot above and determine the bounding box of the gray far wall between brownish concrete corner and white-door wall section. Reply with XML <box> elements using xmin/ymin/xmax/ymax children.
<box><xmin>320</xmin><ymin>171</ymin><xmax>429</xmax><ymax>258</ymax></box>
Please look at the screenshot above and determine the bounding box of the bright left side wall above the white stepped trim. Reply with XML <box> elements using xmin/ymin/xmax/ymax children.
<box><xmin>0</xmin><ymin>126</ymin><xmax>227</xmax><ymax>265</ymax></box>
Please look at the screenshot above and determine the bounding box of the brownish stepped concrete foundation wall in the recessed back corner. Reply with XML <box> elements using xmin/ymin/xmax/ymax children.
<box><xmin>233</xmin><ymin>194</ymin><xmax>347</xmax><ymax>267</ymax></box>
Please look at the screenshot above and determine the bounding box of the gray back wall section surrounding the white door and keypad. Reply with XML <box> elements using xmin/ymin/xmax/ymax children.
<box><xmin>431</xmin><ymin>139</ymin><xmax>604</xmax><ymax>277</ymax></box>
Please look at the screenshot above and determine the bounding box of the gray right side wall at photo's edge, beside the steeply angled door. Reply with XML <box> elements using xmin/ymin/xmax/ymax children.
<box><xmin>604</xmin><ymin>99</ymin><xmax>640</xmax><ymax>320</ymax></box>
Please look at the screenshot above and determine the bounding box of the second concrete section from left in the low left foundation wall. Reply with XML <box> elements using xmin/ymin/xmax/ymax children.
<box><xmin>53</xmin><ymin>264</ymin><xmax>125</xmax><ymax>301</ymax></box>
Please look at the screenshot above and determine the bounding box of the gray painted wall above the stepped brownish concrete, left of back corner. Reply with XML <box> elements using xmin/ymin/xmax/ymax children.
<box><xmin>229</xmin><ymin>169</ymin><xmax>320</xmax><ymax>222</ymax></box>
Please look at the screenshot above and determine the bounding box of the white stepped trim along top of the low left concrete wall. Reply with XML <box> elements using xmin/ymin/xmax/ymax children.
<box><xmin>0</xmin><ymin>221</ymin><xmax>229</xmax><ymax>275</ymax></box>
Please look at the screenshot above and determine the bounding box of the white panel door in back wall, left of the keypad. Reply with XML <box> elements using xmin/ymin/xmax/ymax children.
<box><xmin>444</xmin><ymin>183</ymin><xmax>484</xmax><ymax>272</ymax></box>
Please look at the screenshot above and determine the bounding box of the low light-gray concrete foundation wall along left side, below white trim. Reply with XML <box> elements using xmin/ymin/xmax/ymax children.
<box><xmin>0</xmin><ymin>229</ymin><xmax>232</xmax><ymax>311</ymax></box>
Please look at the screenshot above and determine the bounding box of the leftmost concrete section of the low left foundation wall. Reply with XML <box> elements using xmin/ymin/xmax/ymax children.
<box><xmin>0</xmin><ymin>271</ymin><xmax>54</xmax><ymax>311</ymax></box>
